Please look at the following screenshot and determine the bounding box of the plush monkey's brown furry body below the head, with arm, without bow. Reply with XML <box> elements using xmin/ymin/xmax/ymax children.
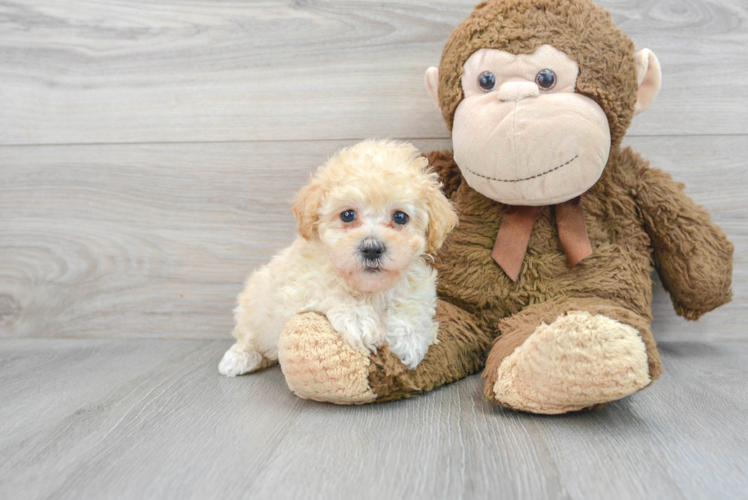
<box><xmin>369</xmin><ymin>143</ymin><xmax>733</xmax><ymax>401</ymax></box>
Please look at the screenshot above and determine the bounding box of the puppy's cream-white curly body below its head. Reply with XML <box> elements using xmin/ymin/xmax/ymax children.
<box><xmin>222</xmin><ymin>238</ymin><xmax>436</xmax><ymax>375</ymax></box>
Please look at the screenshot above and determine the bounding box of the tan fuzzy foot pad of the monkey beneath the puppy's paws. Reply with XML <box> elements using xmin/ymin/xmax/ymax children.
<box><xmin>278</xmin><ymin>313</ymin><xmax>376</xmax><ymax>404</ymax></box>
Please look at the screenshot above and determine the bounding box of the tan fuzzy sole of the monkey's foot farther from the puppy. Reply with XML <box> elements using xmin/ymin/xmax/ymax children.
<box><xmin>493</xmin><ymin>311</ymin><xmax>650</xmax><ymax>414</ymax></box>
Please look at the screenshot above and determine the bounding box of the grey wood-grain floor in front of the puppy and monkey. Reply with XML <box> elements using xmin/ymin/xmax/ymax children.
<box><xmin>0</xmin><ymin>339</ymin><xmax>748</xmax><ymax>500</ymax></box>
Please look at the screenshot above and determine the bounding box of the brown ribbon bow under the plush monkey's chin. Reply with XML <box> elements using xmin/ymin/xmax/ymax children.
<box><xmin>491</xmin><ymin>196</ymin><xmax>592</xmax><ymax>281</ymax></box>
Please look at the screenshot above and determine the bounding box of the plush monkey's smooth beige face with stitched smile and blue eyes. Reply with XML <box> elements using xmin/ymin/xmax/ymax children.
<box><xmin>452</xmin><ymin>45</ymin><xmax>610</xmax><ymax>205</ymax></box>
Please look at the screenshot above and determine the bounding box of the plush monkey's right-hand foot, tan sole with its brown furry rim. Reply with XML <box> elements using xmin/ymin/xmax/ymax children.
<box><xmin>483</xmin><ymin>299</ymin><xmax>662</xmax><ymax>414</ymax></box>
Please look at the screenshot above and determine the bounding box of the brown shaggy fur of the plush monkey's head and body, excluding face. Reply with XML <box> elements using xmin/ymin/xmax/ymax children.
<box><xmin>369</xmin><ymin>0</ymin><xmax>733</xmax><ymax>401</ymax></box>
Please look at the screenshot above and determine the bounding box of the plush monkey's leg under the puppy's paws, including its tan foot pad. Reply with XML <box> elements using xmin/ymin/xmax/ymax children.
<box><xmin>278</xmin><ymin>301</ymin><xmax>492</xmax><ymax>404</ymax></box>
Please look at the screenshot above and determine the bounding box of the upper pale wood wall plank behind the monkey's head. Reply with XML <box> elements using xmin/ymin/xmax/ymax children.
<box><xmin>0</xmin><ymin>0</ymin><xmax>748</xmax><ymax>144</ymax></box>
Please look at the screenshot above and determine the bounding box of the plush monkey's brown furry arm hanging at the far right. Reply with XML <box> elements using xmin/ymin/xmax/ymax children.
<box><xmin>635</xmin><ymin>150</ymin><xmax>734</xmax><ymax>320</ymax></box>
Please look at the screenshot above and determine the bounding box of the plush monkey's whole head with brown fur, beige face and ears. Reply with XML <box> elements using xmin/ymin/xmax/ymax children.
<box><xmin>426</xmin><ymin>0</ymin><xmax>660</xmax><ymax>206</ymax></box>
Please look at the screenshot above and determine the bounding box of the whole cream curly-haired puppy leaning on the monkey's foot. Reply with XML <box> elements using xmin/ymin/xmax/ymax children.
<box><xmin>218</xmin><ymin>140</ymin><xmax>457</xmax><ymax>377</ymax></box>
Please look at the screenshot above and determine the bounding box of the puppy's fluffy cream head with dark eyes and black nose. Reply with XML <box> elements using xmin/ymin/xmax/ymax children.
<box><xmin>293</xmin><ymin>140</ymin><xmax>457</xmax><ymax>292</ymax></box>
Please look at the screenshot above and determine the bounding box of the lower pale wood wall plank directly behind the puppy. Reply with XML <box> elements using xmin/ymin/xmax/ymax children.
<box><xmin>0</xmin><ymin>136</ymin><xmax>748</xmax><ymax>340</ymax></box>
